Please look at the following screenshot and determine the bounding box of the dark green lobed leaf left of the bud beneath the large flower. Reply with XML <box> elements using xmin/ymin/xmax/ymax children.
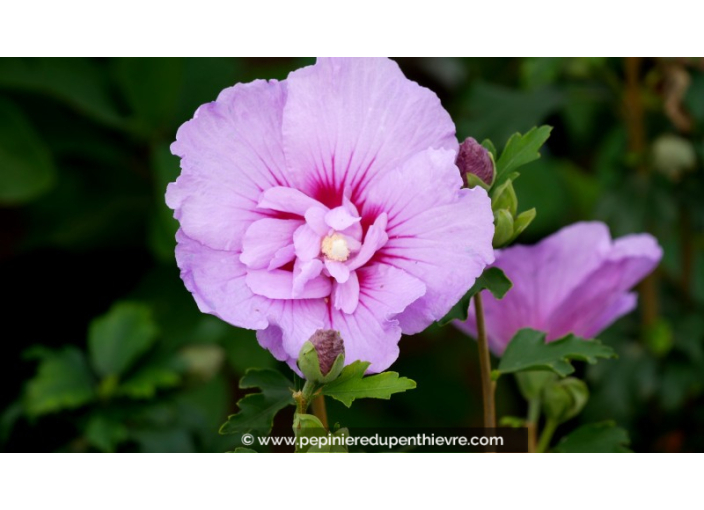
<box><xmin>220</xmin><ymin>368</ymin><xmax>294</xmax><ymax>434</ymax></box>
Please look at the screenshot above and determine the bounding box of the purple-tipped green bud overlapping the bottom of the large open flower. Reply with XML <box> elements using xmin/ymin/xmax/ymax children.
<box><xmin>298</xmin><ymin>329</ymin><xmax>345</xmax><ymax>384</ymax></box>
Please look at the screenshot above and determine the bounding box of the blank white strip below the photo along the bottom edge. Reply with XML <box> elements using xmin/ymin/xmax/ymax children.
<box><xmin>0</xmin><ymin>454</ymin><xmax>702</xmax><ymax>510</ymax></box>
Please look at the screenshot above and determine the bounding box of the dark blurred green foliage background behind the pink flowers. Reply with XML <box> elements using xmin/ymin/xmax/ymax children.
<box><xmin>0</xmin><ymin>58</ymin><xmax>704</xmax><ymax>451</ymax></box>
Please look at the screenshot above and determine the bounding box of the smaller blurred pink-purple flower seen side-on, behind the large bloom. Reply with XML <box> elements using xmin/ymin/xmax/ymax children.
<box><xmin>455</xmin><ymin>222</ymin><xmax>662</xmax><ymax>354</ymax></box>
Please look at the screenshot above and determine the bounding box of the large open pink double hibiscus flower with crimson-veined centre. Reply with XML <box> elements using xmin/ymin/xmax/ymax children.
<box><xmin>166</xmin><ymin>59</ymin><xmax>494</xmax><ymax>372</ymax></box>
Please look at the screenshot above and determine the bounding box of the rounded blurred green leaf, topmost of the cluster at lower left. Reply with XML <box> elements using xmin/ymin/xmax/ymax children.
<box><xmin>88</xmin><ymin>302</ymin><xmax>157</xmax><ymax>377</ymax></box>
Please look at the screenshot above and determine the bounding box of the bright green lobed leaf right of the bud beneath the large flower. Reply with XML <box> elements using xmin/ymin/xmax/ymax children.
<box><xmin>322</xmin><ymin>361</ymin><xmax>416</xmax><ymax>407</ymax></box>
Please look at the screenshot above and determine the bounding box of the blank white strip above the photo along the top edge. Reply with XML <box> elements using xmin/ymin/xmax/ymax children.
<box><xmin>0</xmin><ymin>0</ymin><xmax>701</xmax><ymax>56</ymax></box>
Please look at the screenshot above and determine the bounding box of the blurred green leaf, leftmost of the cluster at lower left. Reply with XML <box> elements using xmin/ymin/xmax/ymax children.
<box><xmin>25</xmin><ymin>347</ymin><xmax>95</xmax><ymax>416</ymax></box>
